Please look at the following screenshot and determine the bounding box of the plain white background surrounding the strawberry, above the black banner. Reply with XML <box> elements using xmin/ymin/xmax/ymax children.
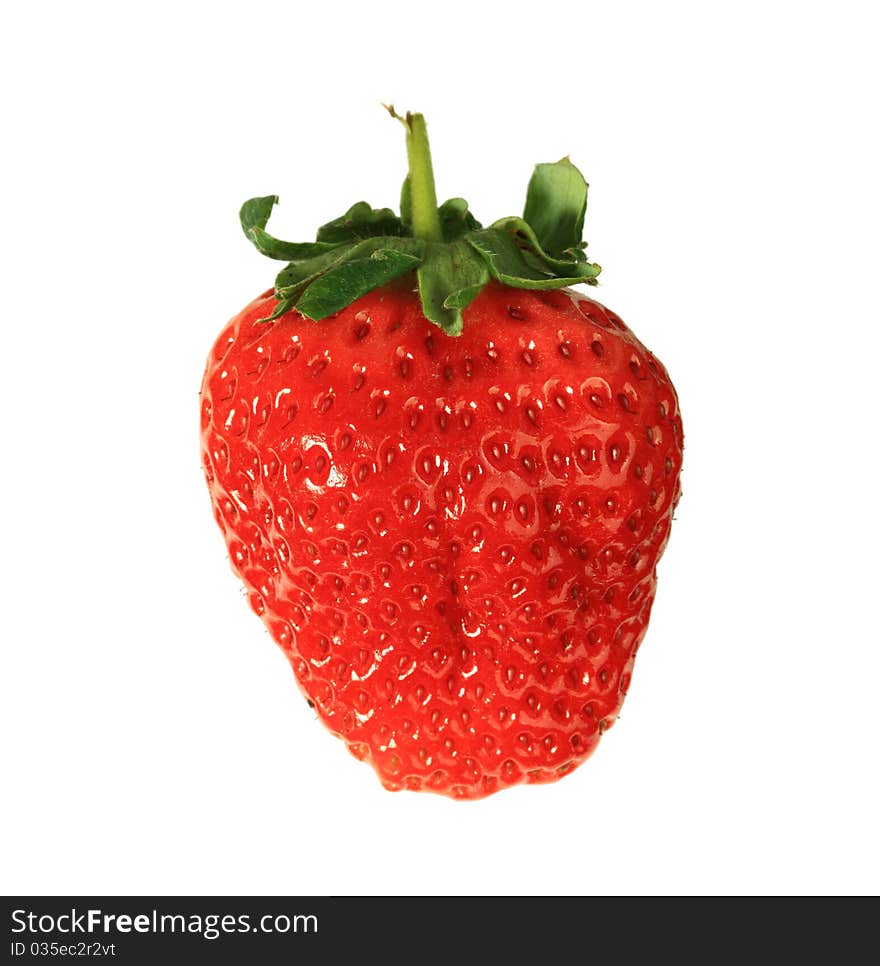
<box><xmin>0</xmin><ymin>0</ymin><xmax>880</xmax><ymax>895</ymax></box>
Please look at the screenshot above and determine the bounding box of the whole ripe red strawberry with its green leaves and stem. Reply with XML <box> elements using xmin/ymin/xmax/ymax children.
<box><xmin>201</xmin><ymin>109</ymin><xmax>682</xmax><ymax>798</ymax></box>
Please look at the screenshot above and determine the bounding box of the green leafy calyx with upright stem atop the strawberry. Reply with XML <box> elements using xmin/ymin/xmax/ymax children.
<box><xmin>239</xmin><ymin>107</ymin><xmax>601</xmax><ymax>336</ymax></box>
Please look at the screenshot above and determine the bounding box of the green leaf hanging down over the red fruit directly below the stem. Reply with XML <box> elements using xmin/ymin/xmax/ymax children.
<box><xmin>418</xmin><ymin>240</ymin><xmax>489</xmax><ymax>336</ymax></box>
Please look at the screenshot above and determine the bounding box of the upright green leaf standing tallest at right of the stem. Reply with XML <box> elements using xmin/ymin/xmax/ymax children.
<box><xmin>523</xmin><ymin>158</ymin><xmax>587</xmax><ymax>258</ymax></box>
